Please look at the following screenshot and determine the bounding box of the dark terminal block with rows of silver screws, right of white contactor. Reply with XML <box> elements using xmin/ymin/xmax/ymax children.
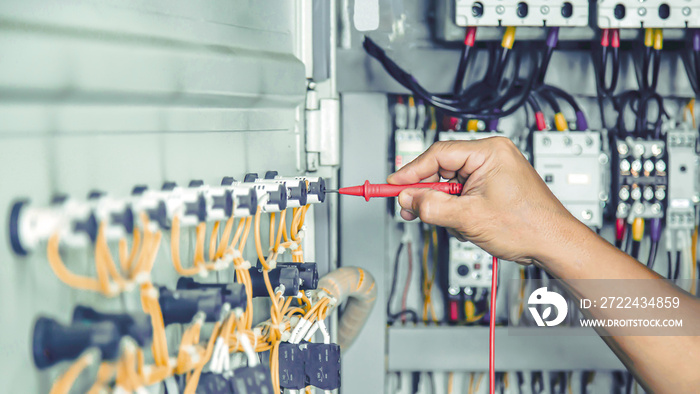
<box><xmin>612</xmin><ymin>138</ymin><xmax>668</xmax><ymax>219</ymax></box>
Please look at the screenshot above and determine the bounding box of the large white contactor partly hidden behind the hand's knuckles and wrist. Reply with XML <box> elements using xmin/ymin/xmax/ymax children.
<box><xmin>533</xmin><ymin>131</ymin><xmax>610</xmax><ymax>228</ymax></box>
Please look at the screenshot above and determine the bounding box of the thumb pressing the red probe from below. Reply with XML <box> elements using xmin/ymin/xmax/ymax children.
<box><xmin>399</xmin><ymin>188</ymin><xmax>463</xmax><ymax>228</ymax></box>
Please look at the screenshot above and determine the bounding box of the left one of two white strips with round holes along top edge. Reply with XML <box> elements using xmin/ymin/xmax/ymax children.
<box><xmin>455</xmin><ymin>0</ymin><xmax>589</xmax><ymax>27</ymax></box>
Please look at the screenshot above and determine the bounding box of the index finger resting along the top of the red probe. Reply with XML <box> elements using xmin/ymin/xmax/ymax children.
<box><xmin>387</xmin><ymin>137</ymin><xmax>490</xmax><ymax>185</ymax></box>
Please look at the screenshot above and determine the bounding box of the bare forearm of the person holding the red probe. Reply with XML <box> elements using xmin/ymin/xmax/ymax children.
<box><xmin>536</xmin><ymin>222</ymin><xmax>700</xmax><ymax>392</ymax></box>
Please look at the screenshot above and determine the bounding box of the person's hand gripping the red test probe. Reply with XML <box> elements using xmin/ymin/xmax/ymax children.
<box><xmin>387</xmin><ymin>137</ymin><xmax>583</xmax><ymax>264</ymax></box>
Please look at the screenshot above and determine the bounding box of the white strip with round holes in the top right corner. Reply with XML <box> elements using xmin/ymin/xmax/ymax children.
<box><xmin>597</xmin><ymin>0</ymin><xmax>700</xmax><ymax>29</ymax></box>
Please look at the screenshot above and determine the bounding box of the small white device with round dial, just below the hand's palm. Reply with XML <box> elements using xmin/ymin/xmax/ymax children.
<box><xmin>448</xmin><ymin>238</ymin><xmax>492</xmax><ymax>294</ymax></box>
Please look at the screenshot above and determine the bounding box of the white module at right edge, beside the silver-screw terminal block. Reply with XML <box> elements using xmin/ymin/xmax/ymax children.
<box><xmin>666</xmin><ymin>129</ymin><xmax>700</xmax><ymax>230</ymax></box>
